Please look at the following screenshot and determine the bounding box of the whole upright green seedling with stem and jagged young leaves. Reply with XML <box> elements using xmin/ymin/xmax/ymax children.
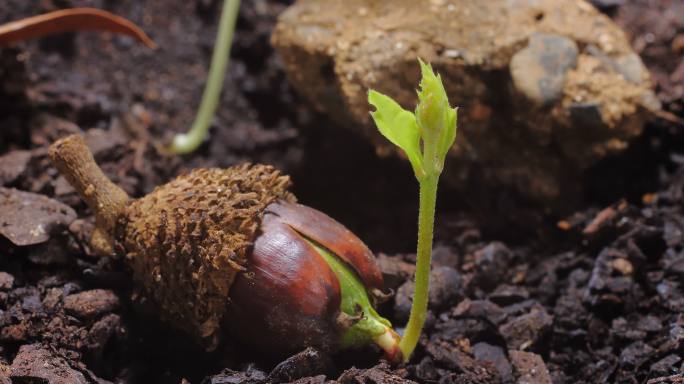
<box><xmin>368</xmin><ymin>59</ymin><xmax>457</xmax><ymax>361</ymax></box>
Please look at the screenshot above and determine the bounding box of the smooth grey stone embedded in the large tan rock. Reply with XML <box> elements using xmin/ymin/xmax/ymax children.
<box><xmin>509</xmin><ymin>33</ymin><xmax>579</xmax><ymax>105</ymax></box>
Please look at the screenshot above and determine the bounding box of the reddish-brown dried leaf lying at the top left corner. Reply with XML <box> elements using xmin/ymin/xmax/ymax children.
<box><xmin>0</xmin><ymin>8</ymin><xmax>157</xmax><ymax>49</ymax></box>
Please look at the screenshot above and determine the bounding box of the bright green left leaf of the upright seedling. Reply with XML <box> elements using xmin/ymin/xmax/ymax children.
<box><xmin>368</xmin><ymin>89</ymin><xmax>424</xmax><ymax>178</ymax></box>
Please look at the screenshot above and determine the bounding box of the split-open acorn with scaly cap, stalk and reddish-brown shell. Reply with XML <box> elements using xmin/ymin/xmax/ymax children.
<box><xmin>49</xmin><ymin>135</ymin><xmax>401</xmax><ymax>362</ymax></box>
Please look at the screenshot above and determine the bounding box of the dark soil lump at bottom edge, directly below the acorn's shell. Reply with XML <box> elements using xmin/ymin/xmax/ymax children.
<box><xmin>268</xmin><ymin>348</ymin><xmax>331</xmax><ymax>383</ymax></box>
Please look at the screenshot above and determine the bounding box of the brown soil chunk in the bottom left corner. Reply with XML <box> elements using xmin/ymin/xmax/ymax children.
<box><xmin>11</xmin><ymin>344</ymin><xmax>88</xmax><ymax>384</ymax></box>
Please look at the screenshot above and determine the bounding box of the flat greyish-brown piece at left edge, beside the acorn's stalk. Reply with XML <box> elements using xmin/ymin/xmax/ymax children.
<box><xmin>0</xmin><ymin>187</ymin><xmax>76</xmax><ymax>246</ymax></box>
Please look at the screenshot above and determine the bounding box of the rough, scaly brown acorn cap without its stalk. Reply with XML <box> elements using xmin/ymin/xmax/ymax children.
<box><xmin>117</xmin><ymin>164</ymin><xmax>295</xmax><ymax>349</ymax></box>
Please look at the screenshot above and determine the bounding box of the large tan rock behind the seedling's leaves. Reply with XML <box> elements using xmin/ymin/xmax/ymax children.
<box><xmin>272</xmin><ymin>0</ymin><xmax>660</xmax><ymax>216</ymax></box>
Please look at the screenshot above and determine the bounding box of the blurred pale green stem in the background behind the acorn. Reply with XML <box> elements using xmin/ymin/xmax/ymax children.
<box><xmin>170</xmin><ymin>0</ymin><xmax>240</xmax><ymax>154</ymax></box>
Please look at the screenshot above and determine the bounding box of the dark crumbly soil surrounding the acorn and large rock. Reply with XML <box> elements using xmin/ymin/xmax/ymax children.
<box><xmin>0</xmin><ymin>0</ymin><xmax>684</xmax><ymax>384</ymax></box>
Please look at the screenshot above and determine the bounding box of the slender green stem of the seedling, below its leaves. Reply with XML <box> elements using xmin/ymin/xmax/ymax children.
<box><xmin>399</xmin><ymin>174</ymin><xmax>439</xmax><ymax>361</ymax></box>
